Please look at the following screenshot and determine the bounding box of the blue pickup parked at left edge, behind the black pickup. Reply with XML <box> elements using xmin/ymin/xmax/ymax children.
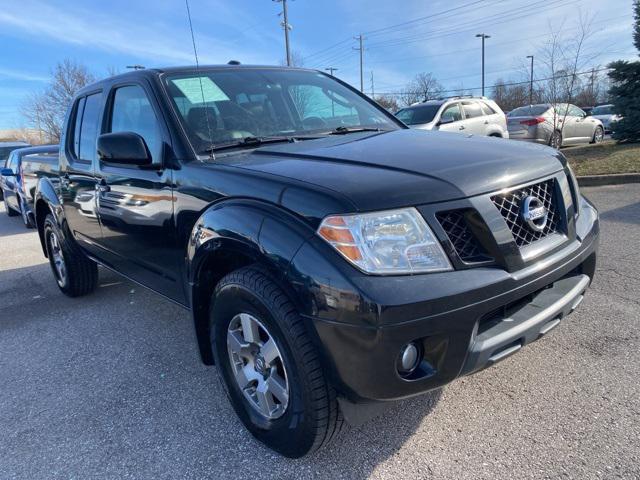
<box><xmin>0</xmin><ymin>145</ymin><xmax>60</xmax><ymax>228</ymax></box>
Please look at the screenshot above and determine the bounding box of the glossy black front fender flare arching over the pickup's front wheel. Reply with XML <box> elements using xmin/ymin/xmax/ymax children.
<box><xmin>185</xmin><ymin>198</ymin><xmax>315</xmax><ymax>365</ymax></box>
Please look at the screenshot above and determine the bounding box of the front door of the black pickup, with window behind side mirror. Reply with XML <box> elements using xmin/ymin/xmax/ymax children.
<box><xmin>96</xmin><ymin>83</ymin><xmax>184</xmax><ymax>303</ymax></box>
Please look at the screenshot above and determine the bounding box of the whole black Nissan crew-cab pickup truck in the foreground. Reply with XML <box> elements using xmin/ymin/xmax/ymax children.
<box><xmin>35</xmin><ymin>65</ymin><xmax>599</xmax><ymax>457</ymax></box>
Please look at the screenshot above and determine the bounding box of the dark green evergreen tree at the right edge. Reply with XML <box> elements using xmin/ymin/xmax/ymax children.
<box><xmin>609</xmin><ymin>0</ymin><xmax>640</xmax><ymax>142</ymax></box>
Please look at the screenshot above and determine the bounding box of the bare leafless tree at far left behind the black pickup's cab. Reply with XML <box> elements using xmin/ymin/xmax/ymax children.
<box><xmin>21</xmin><ymin>59</ymin><xmax>94</xmax><ymax>142</ymax></box>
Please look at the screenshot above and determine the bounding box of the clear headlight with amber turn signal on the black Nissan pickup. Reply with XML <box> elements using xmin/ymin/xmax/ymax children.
<box><xmin>318</xmin><ymin>208</ymin><xmax>452</xmax><ymax>275</ymax></box>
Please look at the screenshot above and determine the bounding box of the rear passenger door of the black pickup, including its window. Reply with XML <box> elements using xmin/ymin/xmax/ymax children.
<box><xmin>59</xmin><ymin>91</ymin><xmax>103</xmax><ymax>254</ymax></box>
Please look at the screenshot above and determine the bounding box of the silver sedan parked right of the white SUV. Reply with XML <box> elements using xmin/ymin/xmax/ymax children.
<box><xmin>507</xmin><ymin>103</ymin><xmax>604</xmax><ymax>148</ymax></box>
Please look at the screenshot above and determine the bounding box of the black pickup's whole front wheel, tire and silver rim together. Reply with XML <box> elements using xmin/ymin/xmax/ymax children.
<box><xmin>210</xmin><ymin>267</ymin><xmax>343</xmax><ymax>458</ymax></box>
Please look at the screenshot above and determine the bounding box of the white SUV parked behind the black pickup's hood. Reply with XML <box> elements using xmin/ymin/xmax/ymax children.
<box><xmin>396</xmin><ymin>97</ymin><xmax>509</xmax><ymax>138</ymax></box>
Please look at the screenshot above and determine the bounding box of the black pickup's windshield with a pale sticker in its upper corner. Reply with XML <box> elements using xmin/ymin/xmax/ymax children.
<box><xmin>165</xmin><ymin>68</ymin><xmax>400</xmax><ymax>154</ymax></box>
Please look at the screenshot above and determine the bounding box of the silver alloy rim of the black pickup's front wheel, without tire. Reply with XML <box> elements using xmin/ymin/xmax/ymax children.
<box><xmin>227</xmin><ymin>313</ymin><xmax>289</xmax><ymax>420</ymax></box>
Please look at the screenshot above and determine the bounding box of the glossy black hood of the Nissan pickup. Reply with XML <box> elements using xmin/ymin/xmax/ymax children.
<box><xmin>216</xmin><ymin>129</ymin><xmax>565</xmax><ymax>211</ymax></box>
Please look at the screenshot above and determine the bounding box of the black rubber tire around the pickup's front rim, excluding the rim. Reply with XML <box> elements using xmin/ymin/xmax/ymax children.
<box><xmin>210</xmin><ymin>267</ymin><xmax>343</xmax><ymax>458</ymax></box>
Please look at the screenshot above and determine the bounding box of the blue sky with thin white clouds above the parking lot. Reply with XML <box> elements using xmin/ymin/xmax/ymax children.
<box><xmin>0</xmin><ymin>0</ymin><xmax>637</xmax><ymax>129</ymax></box>
